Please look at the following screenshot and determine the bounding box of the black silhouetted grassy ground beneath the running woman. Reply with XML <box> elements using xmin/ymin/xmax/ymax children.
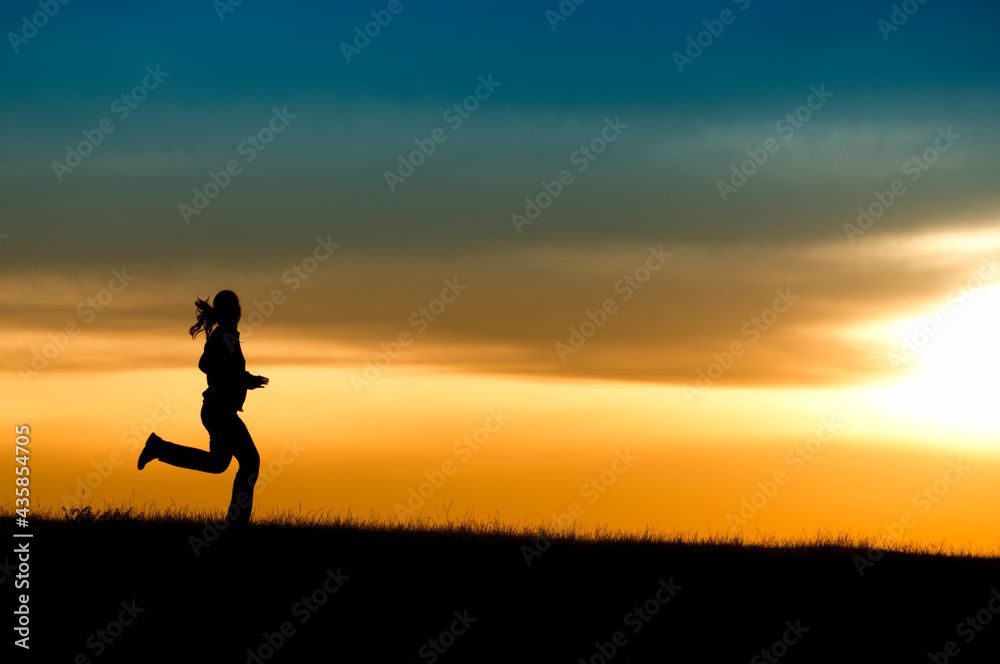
<box><xmin>0</xmin><ymin>519</ymin><xmax>1000</xmax><ymax>664</ymax></box>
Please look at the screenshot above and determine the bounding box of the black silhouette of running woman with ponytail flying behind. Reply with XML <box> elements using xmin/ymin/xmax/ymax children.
<box><xmin>139</xmin><ymin>290</ymin><xmax>268</xmax><ymax>526</ymax></box>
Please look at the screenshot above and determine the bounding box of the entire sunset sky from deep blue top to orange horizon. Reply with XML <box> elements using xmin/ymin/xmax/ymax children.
<box><xmin>0</xmin><ymin>0</ymin><xmax>1000</xmax><ymax>551</ymax></box>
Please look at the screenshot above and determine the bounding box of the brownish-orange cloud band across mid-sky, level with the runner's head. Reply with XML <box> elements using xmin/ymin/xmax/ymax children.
<box><xmin>7</xmin><ymin>228</ymin><xmax>1000</xmax><ymax>385</ymax></box>
